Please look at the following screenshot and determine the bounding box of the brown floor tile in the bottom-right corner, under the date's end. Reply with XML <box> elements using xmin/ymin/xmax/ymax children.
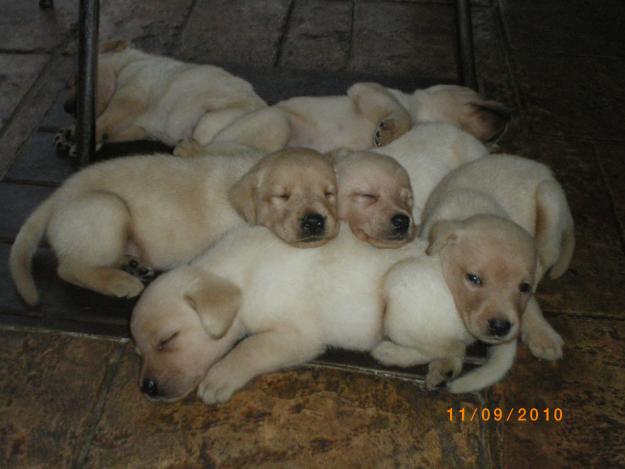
<box><xmin>491</xmin><ymin>317</ymin><xmax>625</xmax><ymax>469</ymax></box>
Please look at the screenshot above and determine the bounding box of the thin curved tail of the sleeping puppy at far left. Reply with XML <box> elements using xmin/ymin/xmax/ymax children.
<box><xmin>9</xmin><ymin>198</ymin><xmax>52</xmax><ymax>305</ymax></box>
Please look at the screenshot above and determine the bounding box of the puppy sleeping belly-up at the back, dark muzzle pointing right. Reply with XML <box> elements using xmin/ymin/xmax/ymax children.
<box><xmin>275</xmin><ymin>83</ymin><xmax>510</xmax><ymax>153</ymax></box>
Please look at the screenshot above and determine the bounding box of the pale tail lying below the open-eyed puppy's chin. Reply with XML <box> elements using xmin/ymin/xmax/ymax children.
<box><xmin>447</xmin><ymin>340</ymin><xmax>517</xmax><ymax>393</ymax></box>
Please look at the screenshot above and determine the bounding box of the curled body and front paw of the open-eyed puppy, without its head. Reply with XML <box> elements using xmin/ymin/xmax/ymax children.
<box><xmin>420</xmin><ymin>155</ymin><xmax>575</xmax><ymax>360</ymax></box>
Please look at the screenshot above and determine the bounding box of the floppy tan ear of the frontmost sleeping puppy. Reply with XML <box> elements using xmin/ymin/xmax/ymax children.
<box><xmin>184</xmin><ymin>269</ymin><xmax>241</xmax><ymax>339</ymax></box>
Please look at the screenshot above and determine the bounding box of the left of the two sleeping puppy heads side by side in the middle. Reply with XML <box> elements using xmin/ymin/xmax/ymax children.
<box><xmin>229</xmin><ymin>148</ymin><xmax>339</xmax><ymax>247</ymax></box>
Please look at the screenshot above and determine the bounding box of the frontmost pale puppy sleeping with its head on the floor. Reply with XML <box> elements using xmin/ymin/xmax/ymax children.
<box><xmin>131</xmin><ymin>226</ymin><xmax>516</xmax><ymax>404</ymax></box>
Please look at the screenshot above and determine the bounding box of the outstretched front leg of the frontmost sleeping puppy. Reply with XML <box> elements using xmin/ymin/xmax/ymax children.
<box><xmin>198</xmin><ymin>329</ymin><xmax>324</xmax><ymax>404</ymax></box>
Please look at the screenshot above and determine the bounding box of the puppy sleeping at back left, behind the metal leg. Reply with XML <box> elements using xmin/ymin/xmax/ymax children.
<box><xmin>55</xmin><ymin>40</ymin><xmax>288</xmax><ymax>156</ymax></box>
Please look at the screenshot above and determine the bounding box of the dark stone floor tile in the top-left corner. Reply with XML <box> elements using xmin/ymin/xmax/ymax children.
<box><xmin>0</xmin><ymin>0</ymin><xmax>78</xmax><ymax>51</ymax></box>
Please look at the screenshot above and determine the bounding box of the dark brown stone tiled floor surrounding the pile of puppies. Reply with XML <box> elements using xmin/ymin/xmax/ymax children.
<box><xmin>0</xmin><ymin>0</ymin><xmax>625</xmax><ymax>469</ymax></box>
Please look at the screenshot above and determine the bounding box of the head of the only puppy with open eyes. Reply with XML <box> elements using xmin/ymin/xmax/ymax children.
<box><xmin>427</xmin><ymin>215</ymin><xmax>538</xmax><ymax>343</ymax></box>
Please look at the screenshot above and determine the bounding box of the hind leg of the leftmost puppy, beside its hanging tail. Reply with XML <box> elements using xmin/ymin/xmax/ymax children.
<box><xmin>48</xmin><ymin>192</ymin><xmax>143</xmax><ymax>298</ymax></box>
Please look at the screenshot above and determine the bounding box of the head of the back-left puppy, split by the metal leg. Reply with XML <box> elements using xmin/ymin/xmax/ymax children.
<box><xmin>63</xmin><ymin>39</ymin><xmax>129</xmax><ymax>116</ymax></box>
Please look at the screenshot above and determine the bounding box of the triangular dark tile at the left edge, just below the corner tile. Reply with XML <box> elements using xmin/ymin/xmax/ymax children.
<box><xmin>0</xmin><ymin>55</ymin><xmax>48</xmax><ymax>129</ymax></box>
